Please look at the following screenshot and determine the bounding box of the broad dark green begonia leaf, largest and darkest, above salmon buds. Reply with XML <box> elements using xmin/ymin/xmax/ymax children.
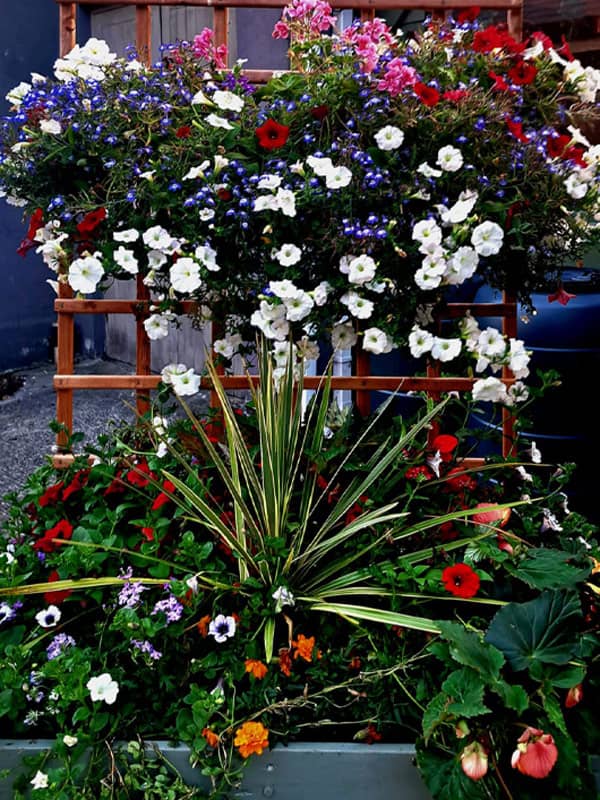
<box><xmin>485</xmin><ymin>591</ymin><xmax>581</xmax><ymax>672</ymax></box>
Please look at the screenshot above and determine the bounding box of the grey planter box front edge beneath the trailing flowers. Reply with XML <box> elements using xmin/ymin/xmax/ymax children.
<box><xmin>0</xmin><ymin>740</ymin><xmax>431</xmax><ymax>800</ymax></box>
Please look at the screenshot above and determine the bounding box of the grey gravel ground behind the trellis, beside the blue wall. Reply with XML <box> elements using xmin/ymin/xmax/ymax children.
<box><xmin>0</xmin><ymin>359</ymin><xmax>211</xmax><ymax>516</ymax></box>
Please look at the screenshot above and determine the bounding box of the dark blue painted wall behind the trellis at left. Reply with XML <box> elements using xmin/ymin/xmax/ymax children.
<box><xmin>0</xmin><ymin>0</ymin><xmax>104</xmax><ymax>371</ymax></box>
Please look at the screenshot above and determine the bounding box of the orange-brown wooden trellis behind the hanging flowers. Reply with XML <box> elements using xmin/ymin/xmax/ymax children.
<box><xmin>54</xmin><ymin>0</ymin><xmax>523</xmax><ymax>466</ymax></box>
